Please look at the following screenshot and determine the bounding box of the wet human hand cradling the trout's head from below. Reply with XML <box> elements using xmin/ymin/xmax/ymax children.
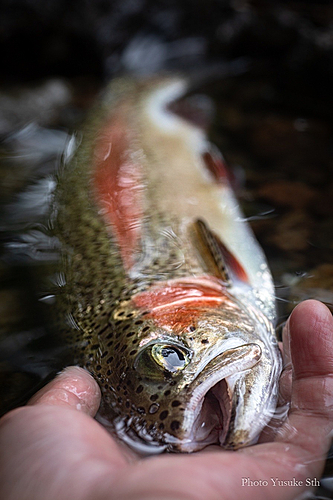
<box><xmin>0</xmin><ymin>300</ymin><xmax>333</xmax><ymax>500</ymax></box>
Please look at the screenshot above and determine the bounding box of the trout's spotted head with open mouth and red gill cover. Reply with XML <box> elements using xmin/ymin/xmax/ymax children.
<box><xmin>102</xmin><ymin>286</ymin><xmax>279</xmax><ymax>452</ymax></box>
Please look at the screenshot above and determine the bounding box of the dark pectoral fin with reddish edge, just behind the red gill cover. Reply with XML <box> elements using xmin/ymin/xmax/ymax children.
<box><xmin>193</xmin><ymin>219</ymin><xmax>248</xmax><ymax>286</ymax></box>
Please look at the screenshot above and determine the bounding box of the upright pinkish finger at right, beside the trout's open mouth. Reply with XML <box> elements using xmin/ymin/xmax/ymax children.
<box><xmin>278</xmin><ymin>300</ymin><xmax>333</xmax><ymax>464</ymax></box>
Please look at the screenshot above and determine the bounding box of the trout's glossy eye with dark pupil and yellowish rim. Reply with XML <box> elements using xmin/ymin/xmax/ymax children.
<box><xmin>134</xmin><ymin>343</ymin><xmax>191</xmax><ymax>380</ymax></box>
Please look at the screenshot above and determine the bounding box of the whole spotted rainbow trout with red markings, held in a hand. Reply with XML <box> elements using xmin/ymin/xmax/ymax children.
<box><xmin>50</xmin><ymin>77</ymin><xmax>281</xmax><ymax>452</ymax></box>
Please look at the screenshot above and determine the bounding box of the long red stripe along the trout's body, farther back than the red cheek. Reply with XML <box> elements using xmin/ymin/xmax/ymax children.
<box><xmin>93</xmin><ymin>105</ymin><xmax>143</xmax><ymax>269</ymax></box>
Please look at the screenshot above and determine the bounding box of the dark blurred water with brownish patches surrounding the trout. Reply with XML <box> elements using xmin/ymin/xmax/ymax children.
<box><xmin>0</xmin><ymin>0</ymin><xmax>333</xmax><ymax>499</ymax></box>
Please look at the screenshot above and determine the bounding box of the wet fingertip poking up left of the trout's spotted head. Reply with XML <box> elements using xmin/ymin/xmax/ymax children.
<box><xmin>28</xmin><ymin>366</ymin><xmax>101</xmax><ymax>417</ymax></box>
